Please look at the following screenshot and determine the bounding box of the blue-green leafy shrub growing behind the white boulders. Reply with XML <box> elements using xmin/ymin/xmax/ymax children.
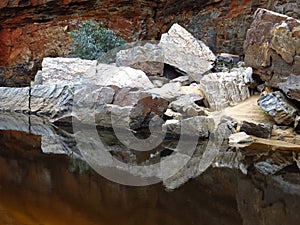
<box><xmin>71</xmin><ymin>21</ymin><xmax>126</xmax><ymax>60</ymax></box>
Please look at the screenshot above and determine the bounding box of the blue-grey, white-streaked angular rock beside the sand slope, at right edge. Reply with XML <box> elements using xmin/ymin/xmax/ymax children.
<box><xmin>257</xmin><ymin>91</ymin><xmax>298</xmax><ymax>126</ymax></box>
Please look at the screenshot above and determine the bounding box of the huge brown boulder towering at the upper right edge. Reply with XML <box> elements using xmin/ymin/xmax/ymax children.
<box><xmin>244</xmin><ymin>9</ymin><xmax>300</xmax><ymax>101</ymax></box>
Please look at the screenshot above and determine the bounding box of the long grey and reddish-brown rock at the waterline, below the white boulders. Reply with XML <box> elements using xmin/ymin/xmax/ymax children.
<box><xmin>72</xmin><ymin>87</ymin><xmax>169</xmax><ymax>129</ymax></box>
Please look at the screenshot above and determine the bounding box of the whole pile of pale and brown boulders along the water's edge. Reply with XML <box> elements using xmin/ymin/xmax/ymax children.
<box><xmin>0</xmin><ymin>14</ymin><xmax>300</xmax><ymax>144</ymax></box>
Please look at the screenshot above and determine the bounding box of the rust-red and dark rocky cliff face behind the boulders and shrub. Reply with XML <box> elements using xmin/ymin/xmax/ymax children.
<box><xmin>0</xmin><ymin>0</ymin><xmax>300</xmax><ymax>85</ymax></box>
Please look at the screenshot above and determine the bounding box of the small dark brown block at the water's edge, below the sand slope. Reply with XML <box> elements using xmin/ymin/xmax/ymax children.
<box><xmin>240</xmin><ymin>121</ymin><xmax>272</xmax><ymax>138</ymax></box>
